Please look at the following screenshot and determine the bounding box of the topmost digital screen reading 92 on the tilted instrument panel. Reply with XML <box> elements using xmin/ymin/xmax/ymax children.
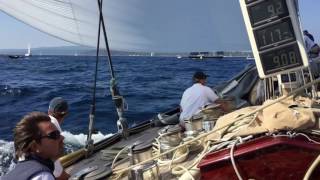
<box><xmin>248</xmin><ymin>0</ymin><xmax>289</xmax><ymax>26</ymax></box>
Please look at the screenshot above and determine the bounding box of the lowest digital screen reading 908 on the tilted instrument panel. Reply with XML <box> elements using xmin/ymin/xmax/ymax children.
<box><xmin>260</xmin><ymin>42</ymin><xmax>303</xmax><ymax>75</ymax></box>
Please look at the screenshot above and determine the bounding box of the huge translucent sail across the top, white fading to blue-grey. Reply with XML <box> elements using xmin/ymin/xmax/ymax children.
<box><xmin>0</xmin><ymin>0</ymin><xmax>250</xmax><ymax>52</ymax></box>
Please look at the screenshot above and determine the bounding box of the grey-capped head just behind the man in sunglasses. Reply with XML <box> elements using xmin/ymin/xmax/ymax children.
<box><xmin>48</xmin><ymin>97</ymin><xmax>69</xmax><ymax>123</ymax></box>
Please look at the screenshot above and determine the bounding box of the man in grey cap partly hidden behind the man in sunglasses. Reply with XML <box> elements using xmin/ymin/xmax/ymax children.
<box><xmin>48</xmin><ymin>97</ymin><xmax>70</xmax><ymax>179</ymax></box>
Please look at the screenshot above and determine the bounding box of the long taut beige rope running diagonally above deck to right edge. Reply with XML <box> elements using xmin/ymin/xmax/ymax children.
<box><xmin>114</xmin><ymin>78</ymin><xmax>320</xmax><ymax>174</ymax></box>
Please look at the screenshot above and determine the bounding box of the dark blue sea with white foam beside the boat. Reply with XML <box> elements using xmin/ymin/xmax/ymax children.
<box><xmin>0</xmin><ymin>56</ymin><xmax>254</xmax><ymax>176</ymax></box>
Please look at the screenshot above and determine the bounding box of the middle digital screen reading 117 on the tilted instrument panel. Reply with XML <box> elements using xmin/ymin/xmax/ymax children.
<box><xmin>254</xmin><ymin>18</ymin><xmax>295</xmax><ymax>50</ymax></box>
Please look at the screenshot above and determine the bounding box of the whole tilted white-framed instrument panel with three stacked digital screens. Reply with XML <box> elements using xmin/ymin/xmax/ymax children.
<box><xmin>240</xmin><ymin>0</ymin><xmax>309</xmax><ymax>77</ymax></box>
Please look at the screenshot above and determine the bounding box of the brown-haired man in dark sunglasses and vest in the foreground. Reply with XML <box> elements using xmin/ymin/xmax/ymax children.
<box><xmin>1</xmin><ymin>112</ymin><xmax>64</xmax><ymax>180</ymax></box>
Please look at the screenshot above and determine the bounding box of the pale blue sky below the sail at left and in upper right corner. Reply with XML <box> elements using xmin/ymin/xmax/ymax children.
<box><xmin>0</xmin><ymin>0</ymin><xmax>320</xmax><ymax>49</ymax></box>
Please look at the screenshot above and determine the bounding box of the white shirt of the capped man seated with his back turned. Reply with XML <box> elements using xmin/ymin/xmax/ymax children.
<box><xmin>180</xmin><ymin>83</ymin><xmax>218</xmax><ymax>121</ymax></box>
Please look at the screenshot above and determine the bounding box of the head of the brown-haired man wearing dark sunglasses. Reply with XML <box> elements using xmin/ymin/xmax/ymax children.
<box><xmin>14</xmin><ymin>112</ymin><xmax>64</xmax><ymax>160</ymax></box>
